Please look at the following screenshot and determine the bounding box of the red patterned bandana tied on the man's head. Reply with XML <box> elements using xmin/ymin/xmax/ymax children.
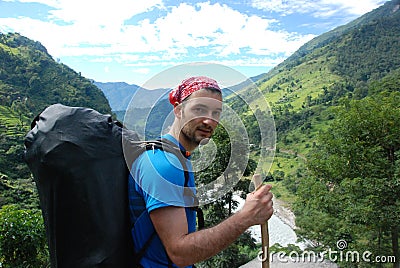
<box><xmin>169</xmin><ymin>76</ymin><xmax>221</xmax><ymax>105</ymax></box>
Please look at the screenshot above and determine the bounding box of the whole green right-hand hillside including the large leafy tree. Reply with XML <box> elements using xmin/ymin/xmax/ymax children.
<box><xmin>234</xmin><ymin>0</ymin><xmax>400</xmax><ymax>267</ymax></box>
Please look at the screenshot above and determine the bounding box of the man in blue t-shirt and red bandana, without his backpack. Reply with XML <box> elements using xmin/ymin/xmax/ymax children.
<box><xmin>129</xmin><ymin>76</ymin><xmax>273</xmax><ymax>267</ymax></box>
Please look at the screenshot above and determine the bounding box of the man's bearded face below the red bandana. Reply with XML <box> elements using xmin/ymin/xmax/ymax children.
<box><xmin>180</xmin><ymin>89</ymin><xmax>222</xmax><ymax>147</ymax></box>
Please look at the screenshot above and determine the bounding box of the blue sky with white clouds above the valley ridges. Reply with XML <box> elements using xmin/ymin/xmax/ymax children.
<box><xmin>0</xmin><ymin>0</ymin><xmax>387</xmax><ymax>85</ymax></box>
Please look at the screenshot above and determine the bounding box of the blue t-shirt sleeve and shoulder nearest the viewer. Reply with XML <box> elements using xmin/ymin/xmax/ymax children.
<box><xmin>132</xmin><ymin>150</ymin><xmax>186</xmax><ymax>212</ymax></box>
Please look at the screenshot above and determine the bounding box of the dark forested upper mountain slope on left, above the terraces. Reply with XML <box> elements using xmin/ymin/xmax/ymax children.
<box><xmin>0</xmin><ymin>33</ymin><xmax>110</xmax><ymax>114</ymax></box>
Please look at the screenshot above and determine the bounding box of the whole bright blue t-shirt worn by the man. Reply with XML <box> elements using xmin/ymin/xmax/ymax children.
<box><xmin>128</xmin><ymin>134</ymin><xmax>196</xmax><ymax>267</ymax></box>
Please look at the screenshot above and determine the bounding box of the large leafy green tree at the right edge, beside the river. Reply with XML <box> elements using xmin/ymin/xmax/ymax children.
<box><xmin>296</xmin><ymin>92</ymin><xmax>400</xmax><ymax>267</ymax></box>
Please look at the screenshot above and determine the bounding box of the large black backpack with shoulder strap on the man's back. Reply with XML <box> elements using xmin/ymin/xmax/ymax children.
<box><xmin>25</xmin><ymin>104</ymin><xmax>200</xmax><ymax>268</ymax></box>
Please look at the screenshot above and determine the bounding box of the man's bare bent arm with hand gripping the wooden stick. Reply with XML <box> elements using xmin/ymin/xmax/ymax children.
<box><xmin>150</xmin><ymin>185</ymin><xmax>273</xmax><ymax>266</ymax></box>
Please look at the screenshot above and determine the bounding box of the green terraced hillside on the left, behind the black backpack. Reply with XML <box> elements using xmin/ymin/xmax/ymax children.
<box><xmin>0</xmin><ymin>33</ymin><xmax>111</xmax><ymax>206</ymax></box>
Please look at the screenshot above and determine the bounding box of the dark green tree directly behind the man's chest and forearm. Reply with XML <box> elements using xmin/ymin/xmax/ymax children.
<box><xmin>193</xmin><ymin>126</ymin><xmax>257</xmax><ymax>268</ymax></box>
